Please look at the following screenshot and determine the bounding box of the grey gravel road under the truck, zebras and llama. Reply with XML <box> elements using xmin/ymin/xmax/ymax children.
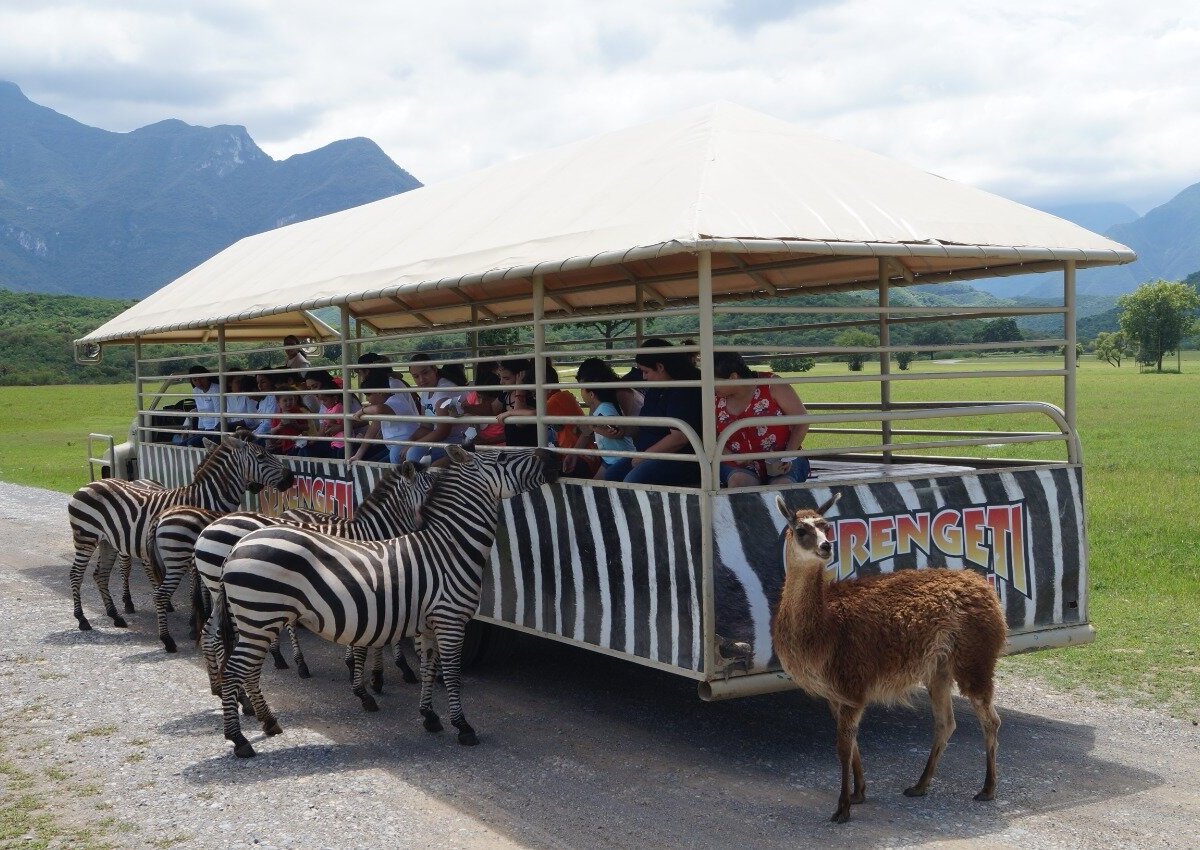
<box><xmin>0</xmin><ymin>484</ymin><xmax>1200</xmax><ymax>850</ymax></box>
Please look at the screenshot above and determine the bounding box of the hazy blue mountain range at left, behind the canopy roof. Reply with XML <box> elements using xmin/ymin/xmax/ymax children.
<box><xmin>0</xmin><ymin>80</ymin><xmax>421</xmax><ymax>298</ymax></box>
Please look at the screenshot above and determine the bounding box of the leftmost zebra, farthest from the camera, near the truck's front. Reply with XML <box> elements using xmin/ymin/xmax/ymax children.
<box><xmin>67</xmin><ymin>435</ymin><xmax>293</xmax><ymax>631</ymax></box>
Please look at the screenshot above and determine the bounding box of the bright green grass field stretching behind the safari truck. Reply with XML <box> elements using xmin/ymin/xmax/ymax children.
<box><xmin>0</xmin><ymin>353</ymin><xmax>1200</xmax><ymax>719</ymax></box>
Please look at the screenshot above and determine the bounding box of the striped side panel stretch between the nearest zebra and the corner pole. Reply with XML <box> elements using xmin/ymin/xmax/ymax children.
<box><xmin>479</xmin><ymin>483</ymin><xmax>704</xmax><ymax>670</ymax></box>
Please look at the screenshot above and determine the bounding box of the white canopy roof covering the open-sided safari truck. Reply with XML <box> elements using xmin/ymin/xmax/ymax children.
<box><xmin>82</xmin><ymin>103</ymin><xmax>1135</xmax><ymax>342</ymax></box>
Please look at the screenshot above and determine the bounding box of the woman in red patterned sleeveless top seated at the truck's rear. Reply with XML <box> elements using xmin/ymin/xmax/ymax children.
<box><xmin>713</xmin><ymin>352</ymin><xmax>810</xmax><ymax>487</ymax></box>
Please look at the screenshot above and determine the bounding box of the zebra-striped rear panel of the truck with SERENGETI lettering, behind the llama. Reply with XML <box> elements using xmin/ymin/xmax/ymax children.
<box><xmin>713</xmin><ymin>467</ymin><xmax>1087</xmax><ymax>671</ymax></box>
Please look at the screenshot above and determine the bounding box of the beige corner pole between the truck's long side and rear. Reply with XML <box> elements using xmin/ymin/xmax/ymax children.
<box><xmin>696</xmin><ymin>251</ymin><xmax>720</xmax><ymax>676</ymax></box>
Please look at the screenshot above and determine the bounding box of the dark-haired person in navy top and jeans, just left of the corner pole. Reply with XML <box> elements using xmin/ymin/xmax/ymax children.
<box><xmin>605</xmin><ymin>339</ymin><xmax>703</xmax><ymax>487</ymax></box>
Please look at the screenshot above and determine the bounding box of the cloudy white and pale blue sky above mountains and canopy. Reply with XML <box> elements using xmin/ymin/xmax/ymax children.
<box><xmin>0</xmin><ymin>0</ymin><xmax>1200</xmax><ymax>213</ymax></box>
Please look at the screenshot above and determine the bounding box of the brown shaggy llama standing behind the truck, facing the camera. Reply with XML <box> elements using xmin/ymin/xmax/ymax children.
<box><xmin>772</xmin><ymin>496</ymin><xmax>1008</xmax><ymax>824</ymax></box>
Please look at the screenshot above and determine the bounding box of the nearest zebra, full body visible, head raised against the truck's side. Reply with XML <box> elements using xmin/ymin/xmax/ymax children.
<box><xmin>214</xmin><ymin>445</ymin><xmax>558</xmax><ymax>758</ymax></box>
